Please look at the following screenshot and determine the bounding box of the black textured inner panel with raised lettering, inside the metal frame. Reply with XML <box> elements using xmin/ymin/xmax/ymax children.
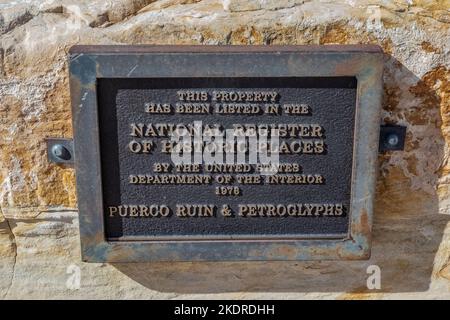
<box><xmin>97</xmin><ymin>77</ymin><xmax>356</xmax><ymax>240</ymax></box>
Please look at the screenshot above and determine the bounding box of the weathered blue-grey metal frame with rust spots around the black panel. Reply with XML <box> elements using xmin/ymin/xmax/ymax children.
<box><xmin>69</xmin><ymin>45</ymin><xmax>383</xmax><ymax>262</ymax></box>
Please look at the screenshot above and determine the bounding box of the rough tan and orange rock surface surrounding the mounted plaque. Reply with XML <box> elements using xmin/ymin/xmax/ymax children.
<box><xmin>0</xmin><ymin>0</ymin><xmax>450</xmax><ymax>298</ymax></box>
